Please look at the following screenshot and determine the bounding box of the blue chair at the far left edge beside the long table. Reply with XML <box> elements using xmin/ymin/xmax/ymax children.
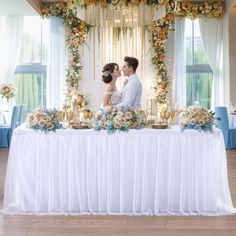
<box><xmin>0</xmin><ymin>106</ymin><xmax>18</xmax><ymax>148</ymax></box>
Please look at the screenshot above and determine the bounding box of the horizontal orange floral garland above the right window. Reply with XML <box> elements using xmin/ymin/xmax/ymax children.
<box><xmin>175</xmin><ymin>1</ymin><xmax>225</xmax><ymax>19</ymax></box>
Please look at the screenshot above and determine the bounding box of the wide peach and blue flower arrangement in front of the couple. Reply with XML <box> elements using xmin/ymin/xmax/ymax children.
<box><xmin>93</xmin><ymin>107</ymin><xmax>146</xmax><ymax>133</ymax></box>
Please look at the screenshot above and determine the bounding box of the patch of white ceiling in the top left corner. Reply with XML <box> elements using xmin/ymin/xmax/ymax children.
<box><xmin>0</xmin><ymin>0</ymin><xmax>38</xmax><ymax>16</ymax></box>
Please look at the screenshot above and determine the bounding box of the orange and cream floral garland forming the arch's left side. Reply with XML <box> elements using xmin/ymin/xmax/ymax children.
<box><xmin>41</xmin><ymin>2</ymin><xmax>89</xmax><ymax>95</ymax></box>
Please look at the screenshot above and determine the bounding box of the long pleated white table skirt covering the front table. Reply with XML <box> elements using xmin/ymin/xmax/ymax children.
<box><xmin>2</xmin><ymin>125</ymin><xmax>234</xmax><ymax>215</ymax></box>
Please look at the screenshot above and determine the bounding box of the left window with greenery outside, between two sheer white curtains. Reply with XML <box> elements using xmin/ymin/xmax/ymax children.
<box><xmin>14</xmin><ymin>16</ymin><xmax>47</xmax><ymax>112</ymax></box>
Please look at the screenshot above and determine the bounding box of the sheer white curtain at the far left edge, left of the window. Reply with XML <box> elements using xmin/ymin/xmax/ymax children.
<box><xmin>0</xmin><ymin>16</ymin><xmax>24</xmax><ymax>113</ymax></box>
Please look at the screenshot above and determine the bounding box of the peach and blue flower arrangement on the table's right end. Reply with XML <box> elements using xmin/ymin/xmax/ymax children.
<box><xmin>179</xmin><ymin>106</ymin><xmax>215</xmax><ymax>132</ymax></box>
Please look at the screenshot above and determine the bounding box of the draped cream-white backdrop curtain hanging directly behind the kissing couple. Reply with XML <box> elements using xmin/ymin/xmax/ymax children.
<box><xmin>80</xmin><ymin>27</ymin><xmax>155</xmax><ymax>110</ymax></box>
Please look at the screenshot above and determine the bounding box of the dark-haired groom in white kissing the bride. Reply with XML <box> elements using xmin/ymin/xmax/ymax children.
<box><xmin>116</xmin><ymin>57</ymin><xmax>142</xmax><ymax>109</ymax></box>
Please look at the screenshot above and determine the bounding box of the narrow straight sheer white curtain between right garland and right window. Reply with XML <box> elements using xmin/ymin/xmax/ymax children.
<box><xmin>173</xmin><ymin>19</ymin><xmax>187</xmax><ymax>108</ymax></box>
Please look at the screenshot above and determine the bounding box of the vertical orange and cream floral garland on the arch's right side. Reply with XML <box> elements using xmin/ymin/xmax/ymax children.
<box><xmin>152</xmin><ymin>0</ymin><xmax>175</xmax><ymax>104</ymax></box>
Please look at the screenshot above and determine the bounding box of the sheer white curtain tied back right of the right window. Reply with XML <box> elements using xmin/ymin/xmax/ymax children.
<box><xmin>199</xmin><ymin>19</ymin><xmax>224</xmax><ymax>108</ymax></box>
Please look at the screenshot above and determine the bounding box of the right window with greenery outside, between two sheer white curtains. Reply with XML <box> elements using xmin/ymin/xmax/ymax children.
<box><xmin>185</xmin><ymin>19</ymin><xmax>213</xmax><ymax>109</ymax></box>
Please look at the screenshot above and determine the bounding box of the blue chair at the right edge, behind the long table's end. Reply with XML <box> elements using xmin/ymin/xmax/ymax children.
<box><xmin>215</xmin><ymin>107</ymin><xmax>236</xmax><ymax>149</ymax></box>
